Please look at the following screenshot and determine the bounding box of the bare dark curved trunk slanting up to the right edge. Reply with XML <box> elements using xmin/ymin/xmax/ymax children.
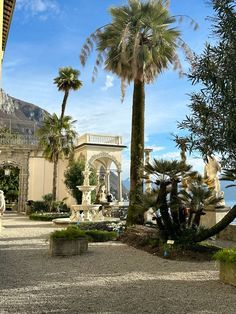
<box><xmin>194</xmin><ymin>205</ymin><xmax>236</xmax><ymax>242</ymax></box>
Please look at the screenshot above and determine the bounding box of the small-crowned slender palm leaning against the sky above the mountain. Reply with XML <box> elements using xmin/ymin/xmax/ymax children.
<box><xmin>54</xmin><ymin>67</ymin><xmax>83</xmax><ymax>120</ymax></box>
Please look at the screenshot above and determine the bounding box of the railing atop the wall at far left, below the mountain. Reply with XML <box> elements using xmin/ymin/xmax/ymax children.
<box><xmin>0</xmin><ymin>134</ymin><xmax>38</xmax><ymax>146</ymax></box>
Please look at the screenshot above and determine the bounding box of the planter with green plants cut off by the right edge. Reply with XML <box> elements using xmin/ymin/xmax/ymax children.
<box><xmin>213</xmin><ymin>248</ymin><xmax>236</xmax><ymax>286</ymax></box>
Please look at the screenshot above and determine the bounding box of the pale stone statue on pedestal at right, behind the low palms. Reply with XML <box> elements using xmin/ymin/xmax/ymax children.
<box><xmin>204</xmin><ymin>156</ymin><xmax>222</xmax><ymax>197</ymax></box>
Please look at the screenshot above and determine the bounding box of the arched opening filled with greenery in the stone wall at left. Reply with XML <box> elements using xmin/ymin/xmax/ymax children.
<box><xmin>0</xmin><ymin>162</ymin><xmax>20</xmax><ymax>210</ymax></box>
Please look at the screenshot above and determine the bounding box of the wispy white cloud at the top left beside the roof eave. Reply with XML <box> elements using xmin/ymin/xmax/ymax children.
<box><xmin>16</xmin><ymin>0</ymin><xmax>60</xmax><ymax>18</ymax></box>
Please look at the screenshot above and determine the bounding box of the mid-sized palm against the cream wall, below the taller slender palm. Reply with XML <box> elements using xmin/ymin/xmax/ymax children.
<box><xmin>37</xmin><ymin>113</ymin><xmax>76</xmax><ymax>200</ymax></box>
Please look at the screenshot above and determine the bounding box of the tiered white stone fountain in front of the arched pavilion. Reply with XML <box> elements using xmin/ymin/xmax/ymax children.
<box><xmin>70</xmin><ymin>163</ymin><xmax>104</xmax><ymax>222</ymax></box>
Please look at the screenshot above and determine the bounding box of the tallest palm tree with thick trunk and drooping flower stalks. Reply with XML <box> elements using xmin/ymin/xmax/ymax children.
<box><xmin>80</xmin><ymin>0</ymin><xmax>195</xmax><ymax>222</ymax></box>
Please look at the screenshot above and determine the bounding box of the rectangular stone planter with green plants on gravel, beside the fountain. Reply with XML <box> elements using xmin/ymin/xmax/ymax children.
<box><xmin>50</xmin><ymin>226</ymin><xmax>88</xmax><ymax>256</ymax></box>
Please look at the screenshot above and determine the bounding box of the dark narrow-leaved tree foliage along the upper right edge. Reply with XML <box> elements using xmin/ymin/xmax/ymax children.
<box><xmin>179</xmin><ymin>0</ymin><xmax>236</xmax><ymax>167</ymax></box>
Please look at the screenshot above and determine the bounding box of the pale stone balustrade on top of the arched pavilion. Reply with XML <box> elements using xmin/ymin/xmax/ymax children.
<box><xmin>77</xmin><ymin>133</ymin><xmax>122</xmax><ymax>145</ymax></box>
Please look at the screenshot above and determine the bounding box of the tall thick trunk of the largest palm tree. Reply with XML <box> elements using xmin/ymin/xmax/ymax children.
<box><xmin>130</xmin><ymin>79</ymin><xmax>145</xmax><ymax>205</ymax></box>
